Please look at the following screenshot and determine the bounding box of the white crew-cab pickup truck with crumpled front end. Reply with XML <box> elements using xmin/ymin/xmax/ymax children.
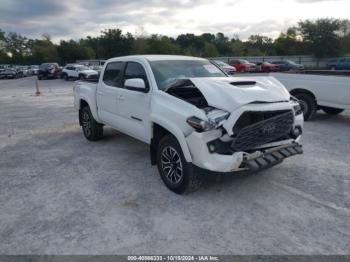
<box><xmin>74</xmin><ymin>55</ymin><xmax>303</xmax><ymax>194</ymax></box>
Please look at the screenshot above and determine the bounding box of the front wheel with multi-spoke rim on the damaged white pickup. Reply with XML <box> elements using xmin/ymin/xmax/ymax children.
<box><xmin>157</xmin><ymin>135</ymin><xmax>201</xmax><ymax>194</ymax></box>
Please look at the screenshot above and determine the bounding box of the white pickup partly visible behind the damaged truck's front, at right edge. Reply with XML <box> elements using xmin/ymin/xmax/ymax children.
<box><xmin>270</xmin><ymin>73</ymin><xmax>350</xmax><ymax>120</ymax></box>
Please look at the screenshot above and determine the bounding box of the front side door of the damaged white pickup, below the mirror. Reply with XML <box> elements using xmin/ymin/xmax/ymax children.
<box><xmin>117</xmin><ymin>61</ymin><xmax>150</xmax><ymax>143</ymax></box>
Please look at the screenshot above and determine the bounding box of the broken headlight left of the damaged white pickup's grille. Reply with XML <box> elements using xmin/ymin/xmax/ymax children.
<box><xmin>187</xmin><ymin>112</ymin><xmax>230</xmax><ymax>132</ymax></box>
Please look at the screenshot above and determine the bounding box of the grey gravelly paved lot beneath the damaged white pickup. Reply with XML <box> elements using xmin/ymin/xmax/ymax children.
<box><xmin>0</xmin><ymin>78</ymin><xmax>350</xmax><ymax>254</ymax></box>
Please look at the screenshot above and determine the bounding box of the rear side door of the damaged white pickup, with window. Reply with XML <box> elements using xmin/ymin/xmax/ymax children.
<box><xmin>96</xmin><ymin>62</ymin><xmax>124</xmax><ymax>128</ymax></box>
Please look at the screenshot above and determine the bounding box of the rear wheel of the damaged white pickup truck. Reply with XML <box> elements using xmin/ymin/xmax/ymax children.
<box><xmin>79</xmin><ymin>106</ymin><xmax>103</xmax><ymax>141</ymax></box>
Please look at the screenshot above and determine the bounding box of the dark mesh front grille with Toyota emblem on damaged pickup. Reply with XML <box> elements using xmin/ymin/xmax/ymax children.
<box><xmin>231</xmin><ymin>111</ymin><xmax>294</xmax><ymax>151</ymax></box>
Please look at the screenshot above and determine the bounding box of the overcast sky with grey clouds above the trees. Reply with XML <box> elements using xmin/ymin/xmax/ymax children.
<box><xmin>0</xmin><ymin>0</ymin><xmax>350</xmax><ymax>41</ymax></box>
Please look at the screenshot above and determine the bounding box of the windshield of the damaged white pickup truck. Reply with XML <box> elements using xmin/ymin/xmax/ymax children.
<box><xmin>150</xmin><ymin>60</ymin><xmax>226</xmax><ymax>90</ymax></box>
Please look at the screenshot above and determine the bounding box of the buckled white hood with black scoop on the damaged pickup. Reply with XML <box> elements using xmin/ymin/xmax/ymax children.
<box><xmin>190</xmin><ymin>76</ymin><xmax>290</xmax><ymax>112</ymax></box>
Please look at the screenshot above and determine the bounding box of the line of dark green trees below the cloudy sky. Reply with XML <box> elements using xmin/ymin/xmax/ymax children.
<box><xmin>0</xmin><ymin>18</ymin><xmax>350</xmax><ymax>64</ymax></box>
